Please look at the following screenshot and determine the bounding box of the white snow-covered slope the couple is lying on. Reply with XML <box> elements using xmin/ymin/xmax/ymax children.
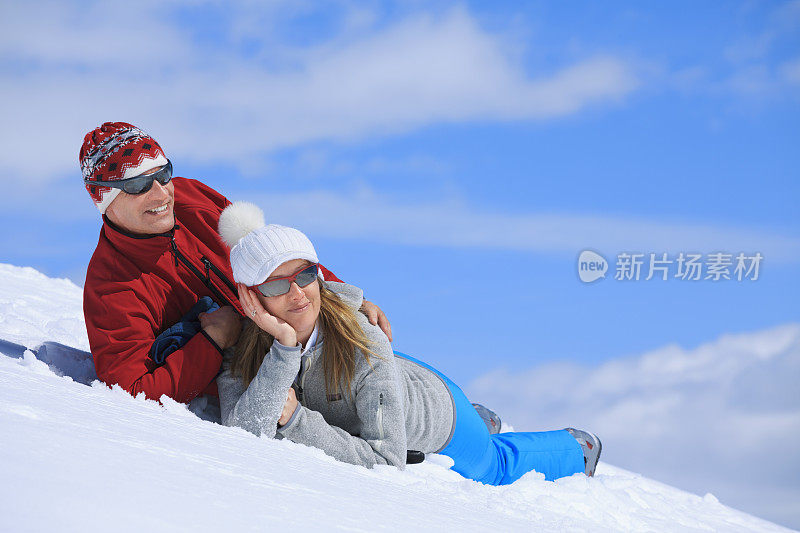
<box><xmin>0</xmin><ymin>265</ymin><xmax>788</xmax><ymax>531</ymax></box>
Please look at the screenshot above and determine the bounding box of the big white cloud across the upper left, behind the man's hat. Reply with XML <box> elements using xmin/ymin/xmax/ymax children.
<box><xmin>0</xmin><ymin>3</ymin><xmax>637</xmax><ymax>183</ymax></box>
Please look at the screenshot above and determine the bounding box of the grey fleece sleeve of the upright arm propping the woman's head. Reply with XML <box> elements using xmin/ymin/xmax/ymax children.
<box><xmin>217</xmin><ymin>341</ymin><xmax>300</xmax><ymax>438</ymax></box>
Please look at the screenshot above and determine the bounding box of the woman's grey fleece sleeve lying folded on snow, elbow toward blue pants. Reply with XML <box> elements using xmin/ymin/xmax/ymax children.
<box><xmin>278</xmin><ymin>319</ymin><xmax>407</xmax><ymax>469</ymax></box>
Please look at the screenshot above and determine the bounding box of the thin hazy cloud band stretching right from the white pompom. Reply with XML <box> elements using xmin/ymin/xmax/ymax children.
<box><xmin>238</xmin><ymin>189</ymin><xmax>800</xmax><ymax>264</ymax></box>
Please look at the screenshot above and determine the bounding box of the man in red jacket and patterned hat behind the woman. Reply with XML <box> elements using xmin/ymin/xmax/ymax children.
<box><xmin>78</xmin><ymin>122</ymin><xmax>391</xmax><ymax>402</ymax></box>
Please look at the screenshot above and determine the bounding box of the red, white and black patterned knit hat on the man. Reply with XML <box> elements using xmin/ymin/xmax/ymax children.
<box><xmin>78</xmin><ymin>122</ymin><xmax>167</xmax><ymax>214</ymax></box>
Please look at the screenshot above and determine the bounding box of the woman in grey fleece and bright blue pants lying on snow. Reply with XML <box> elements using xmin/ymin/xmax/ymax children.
<box><xmin>217</xmin><ymin>202</ymin><xmax>601</xmax><ymax>485</ymax></box>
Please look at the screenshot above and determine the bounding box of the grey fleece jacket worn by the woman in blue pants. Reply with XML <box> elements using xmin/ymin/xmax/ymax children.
<box><xmin>217</xmin><ymin>282</ymin><xmax>455</xmax><ymax>468</ymax></box>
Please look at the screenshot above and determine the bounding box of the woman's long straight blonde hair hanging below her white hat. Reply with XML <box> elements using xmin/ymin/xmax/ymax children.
<box><xmin>231</xmin><ymin>281</ymin><xmax>378</xmax><ymax>397</ymax></box>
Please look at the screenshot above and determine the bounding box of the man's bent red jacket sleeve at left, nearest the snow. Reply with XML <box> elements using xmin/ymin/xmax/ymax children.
<box><xmin>83</xmin><ymin>278</ymin><xmax>222</xmax><ymax>402</ymax></box>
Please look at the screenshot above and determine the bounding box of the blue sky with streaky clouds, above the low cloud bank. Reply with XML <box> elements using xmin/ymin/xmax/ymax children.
<box><xmin>0</xmin><ymin>2</ymin><xmax>800</xmax><ymax>383</ymax></box>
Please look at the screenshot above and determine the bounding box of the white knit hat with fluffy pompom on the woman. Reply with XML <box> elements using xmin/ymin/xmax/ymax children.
<box><xmin>219</xmin><ymin>202</ymin><xmax>322</xmax><ymax>287</ymax></box>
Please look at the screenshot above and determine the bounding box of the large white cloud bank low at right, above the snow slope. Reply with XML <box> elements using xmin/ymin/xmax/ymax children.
<box><xmin>468</xmin><ymin>324</ymin><xmax>800</xmax><ymax>525</ymax></box>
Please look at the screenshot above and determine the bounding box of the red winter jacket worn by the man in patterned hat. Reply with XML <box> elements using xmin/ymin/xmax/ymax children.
<box><xmin>83</xmin><ymin>177</ymin><xmax>338</xmax><ymax>402</ymax></box>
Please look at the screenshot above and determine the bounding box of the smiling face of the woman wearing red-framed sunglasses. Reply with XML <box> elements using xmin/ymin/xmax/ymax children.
<box><xmin>256</xmin><ymin>259</ymin><xmax>320</xmax><ymax>343</ymax></box>
